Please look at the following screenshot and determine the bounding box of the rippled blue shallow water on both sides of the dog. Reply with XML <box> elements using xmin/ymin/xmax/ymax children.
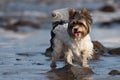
<box><xmin>0</xmin><ymin>25</ymin><xmax>120</xmax><ymax>80</ymax></box>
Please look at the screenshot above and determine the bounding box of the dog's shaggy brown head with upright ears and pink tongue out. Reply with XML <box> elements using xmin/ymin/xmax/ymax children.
<box><xmin>68</xmin><ymin>8</ymin><xmax>92</xmax><ymax>39</ymax></box>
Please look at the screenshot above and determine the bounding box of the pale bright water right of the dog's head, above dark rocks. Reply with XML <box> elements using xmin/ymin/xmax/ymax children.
<box><xmin>91</xmin><ymin>24</ymin><xmax>120</xmax><ymax>48</ymax></box>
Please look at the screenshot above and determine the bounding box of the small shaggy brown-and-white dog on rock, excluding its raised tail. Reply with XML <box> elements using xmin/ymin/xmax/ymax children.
<box><xmin>51</xmin><ymin>8</ymin><xmax>93</xmax><ymax>69</ymax></box>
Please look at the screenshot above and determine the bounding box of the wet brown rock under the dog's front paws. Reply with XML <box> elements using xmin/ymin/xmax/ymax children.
<box><xmin>47</xmin><ymin>65</ymin><xmax>94</xmax><ymax>80</ymax></box>
